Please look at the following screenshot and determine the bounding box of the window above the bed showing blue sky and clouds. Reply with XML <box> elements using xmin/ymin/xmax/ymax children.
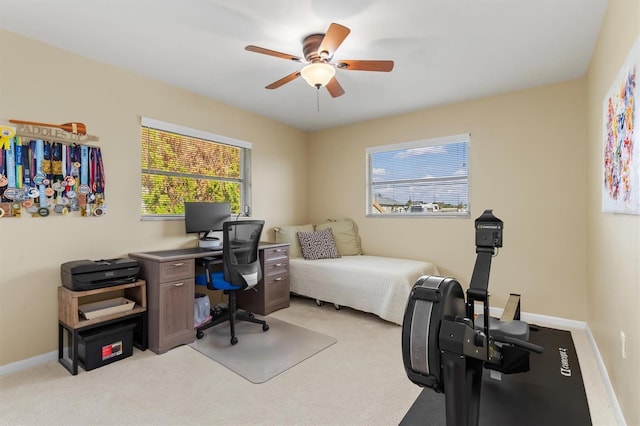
<box><xmin>366</xmin><ymin>134</ymin><xmax>470</xmax><ymax>217</ymax></box>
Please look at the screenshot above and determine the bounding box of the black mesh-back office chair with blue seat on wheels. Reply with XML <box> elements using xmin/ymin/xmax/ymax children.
<box><xmin>196</xmin><ymin>220</ymin><xmax>269</xmax><ymax>345</ymax></box>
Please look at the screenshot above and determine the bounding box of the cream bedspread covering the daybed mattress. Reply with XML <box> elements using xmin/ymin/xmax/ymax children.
<box><xmin>289</xmin><ymin>256</ymin><xmax>439</xmax><ymax>325</ymax></box>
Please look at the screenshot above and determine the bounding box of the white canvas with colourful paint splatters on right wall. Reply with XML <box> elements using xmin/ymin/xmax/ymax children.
<box><xmin>602</xmin><ymin>38</ymin><xmax>640</xmax><ymax>215</ymax></box>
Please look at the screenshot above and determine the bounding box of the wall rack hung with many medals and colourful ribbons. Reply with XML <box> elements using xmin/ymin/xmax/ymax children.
<box><xmin>0</xmin><ymin>120</ymin><xmax>106</xmax><ymax>218</ymax></box>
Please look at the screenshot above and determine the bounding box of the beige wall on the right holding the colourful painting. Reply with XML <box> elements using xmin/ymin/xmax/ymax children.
<box><xmin>587</xmin><ymin>0</ymin><xmax>640</xmax><ymax>425</ymax></box>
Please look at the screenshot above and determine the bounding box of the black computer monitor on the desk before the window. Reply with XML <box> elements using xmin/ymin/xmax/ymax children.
<box><xmin>184</xmin><ymin>201</ymin><xmax>231</xmax><ymax>246</ymax></box>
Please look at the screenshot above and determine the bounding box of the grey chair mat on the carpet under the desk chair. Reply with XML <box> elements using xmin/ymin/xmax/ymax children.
<box><xmin>189</xmin><ymin>317</ymin><xmax>336</xmax><ymax>383</ymax></box>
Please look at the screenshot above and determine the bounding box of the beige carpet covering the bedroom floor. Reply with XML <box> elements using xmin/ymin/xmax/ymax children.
<box><xmin>0</xmin><ymin>298</ymin><xmax>615</xmax><ymax>426</ymax></box>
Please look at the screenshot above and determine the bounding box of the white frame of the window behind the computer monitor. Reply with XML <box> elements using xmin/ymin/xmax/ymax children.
<box><xmin>139</xmin><ymin>116</ymin><xmax>253</xmax><ymax>221</ymax></box>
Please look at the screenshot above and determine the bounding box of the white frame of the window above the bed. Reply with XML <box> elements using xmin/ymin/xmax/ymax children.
<box><xmin>365</xmin><ymin>133</ymin><xmax>471</xmax><ymax>219</ymax></box>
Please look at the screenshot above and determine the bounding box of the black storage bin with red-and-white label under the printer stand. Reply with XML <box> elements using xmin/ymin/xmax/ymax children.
<box><xmin>78</xmin><ymin>322</ymin><xmax>136</xmax><ymax>371</ymax></box>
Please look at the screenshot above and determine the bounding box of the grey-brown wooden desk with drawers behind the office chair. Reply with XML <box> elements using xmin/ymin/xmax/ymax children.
<box><xmin>129</xmin><ymin>242</ymin><xmax>289</xmax><ymax>354</ymax></box>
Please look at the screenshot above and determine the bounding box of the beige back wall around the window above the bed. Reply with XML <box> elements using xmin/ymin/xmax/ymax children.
<box><xmin>308</xmin><ymin>79</ymin><xmax>586</xmax><ymax>320</ymax></box>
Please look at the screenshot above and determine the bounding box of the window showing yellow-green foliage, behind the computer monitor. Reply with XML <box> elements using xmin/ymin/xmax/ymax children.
<box><xmin>140</xmin><ymin>117</ymin><xmax>251</xmax><ymax>219</ymax></box>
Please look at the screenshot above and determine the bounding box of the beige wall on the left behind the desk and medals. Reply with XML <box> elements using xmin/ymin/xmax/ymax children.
<box><xmin>0</xmin><ymin>31</ymin><xmax>307</xmax><ymax>365</ymax></box>
